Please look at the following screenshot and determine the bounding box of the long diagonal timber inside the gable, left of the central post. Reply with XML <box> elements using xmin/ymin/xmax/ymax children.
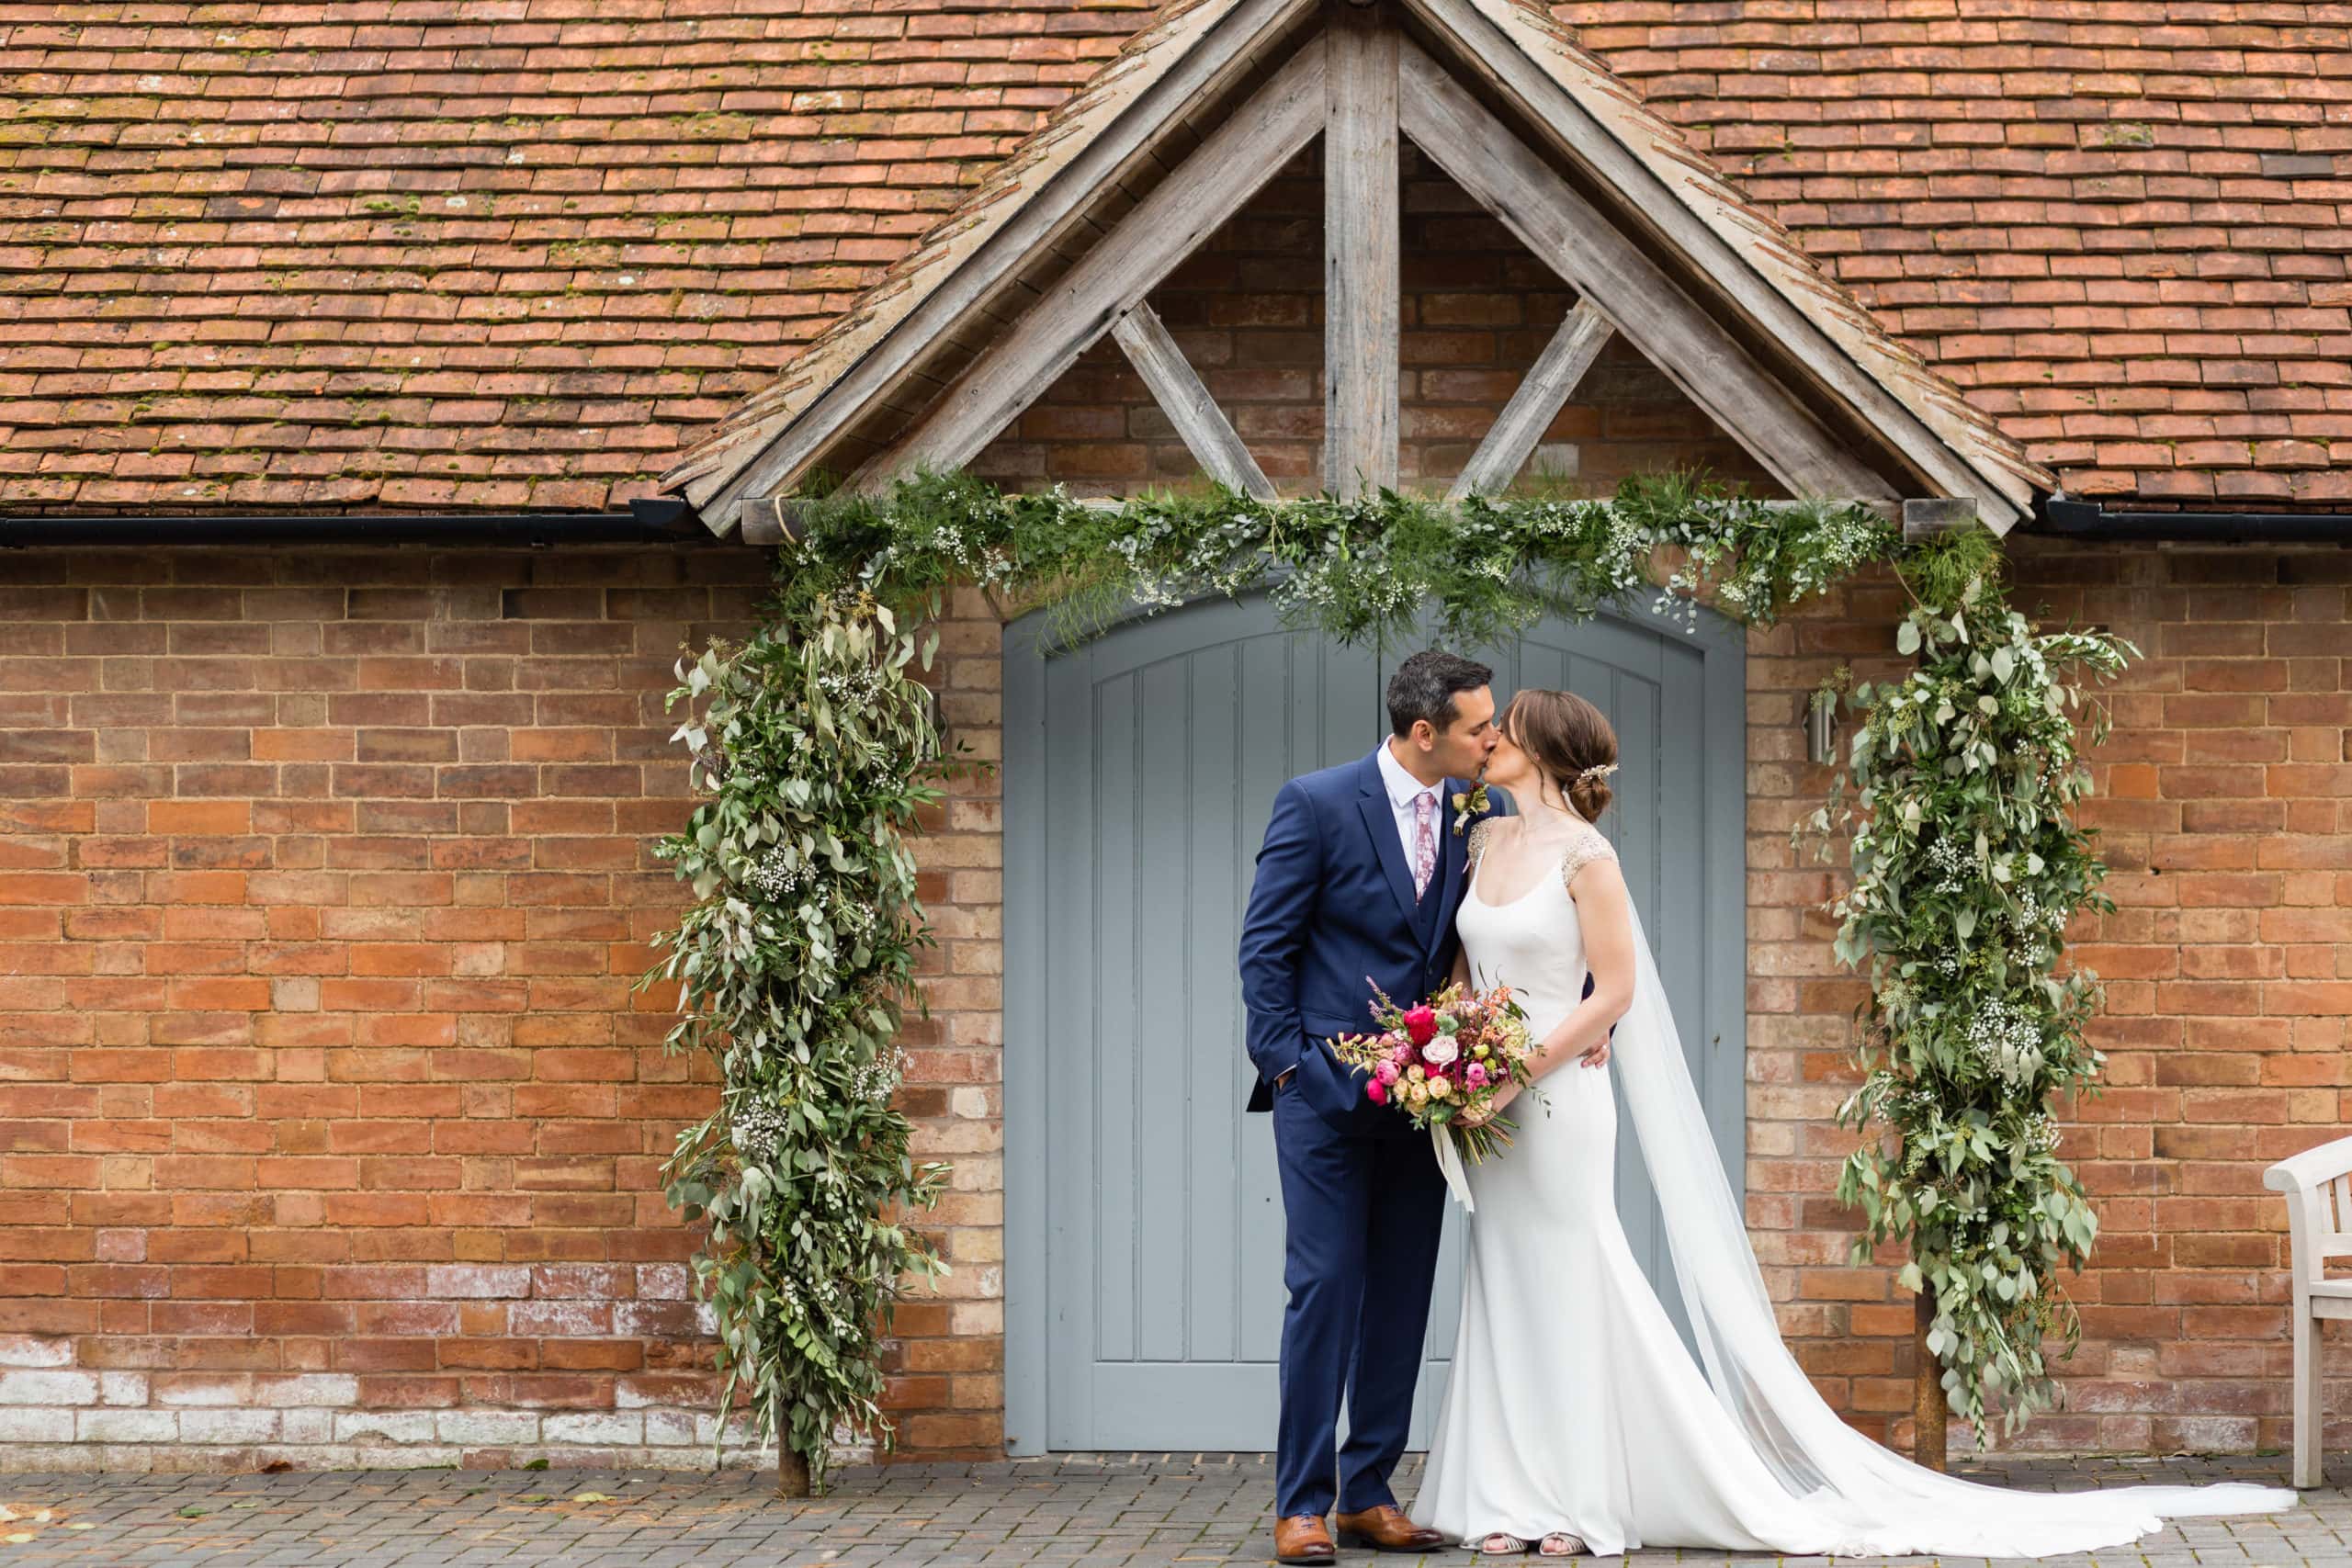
<box><xmin>849</xmin><ymin>38</ymin><xmax>1324</xmax><ymax>491</ymax></box>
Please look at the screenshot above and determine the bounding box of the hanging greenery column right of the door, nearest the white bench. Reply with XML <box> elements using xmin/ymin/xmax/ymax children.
<box><xmin>1799</xmin><ymin>531</ymin><xmax>2138</xmax><ymax>1441</ymax></box>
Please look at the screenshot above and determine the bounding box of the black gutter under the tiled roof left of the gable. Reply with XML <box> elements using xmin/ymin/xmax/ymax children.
<box><xmin>0</xmin><ymin>496</ymin><xmax>713</xmax><ymax>550</ymax></box>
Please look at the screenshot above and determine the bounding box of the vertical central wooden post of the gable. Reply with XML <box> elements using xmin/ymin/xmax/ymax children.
<box><xmin>1324</xmin><ymin>5</ymin><xmax>1404</xmax><ymax>499</ymax></box>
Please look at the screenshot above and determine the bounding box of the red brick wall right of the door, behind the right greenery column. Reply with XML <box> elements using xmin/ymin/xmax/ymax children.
<box><xmin>1747</xmin><ymin>541</ymin><xmax>2352</xmax><ymax>1453</ymax></box>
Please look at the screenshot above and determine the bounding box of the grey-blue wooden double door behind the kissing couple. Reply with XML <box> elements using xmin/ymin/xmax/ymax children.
<box><xmin>1004</xmin><ymin>600</ymin><xmax>1746</xmax><ymax>1453</ymax></box>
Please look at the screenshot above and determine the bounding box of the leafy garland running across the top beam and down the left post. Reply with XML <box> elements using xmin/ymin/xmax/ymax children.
<box><xmin>639</xmin><ymin>472</ymin><xmax>2126</xmax><ymax>1485</ymax></box>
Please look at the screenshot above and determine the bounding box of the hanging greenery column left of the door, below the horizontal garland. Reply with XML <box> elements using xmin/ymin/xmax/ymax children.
<box><xmin>639</xmin><ymin>597</ymin><xmax>948</xmax><ymax>1493</ymax></box>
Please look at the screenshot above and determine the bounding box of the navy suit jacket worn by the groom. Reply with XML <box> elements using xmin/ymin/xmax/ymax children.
<box><xmin>1242</xmin><ymin>740</ymin><xmax>1467</xmax><ymax>1135</ymax></box>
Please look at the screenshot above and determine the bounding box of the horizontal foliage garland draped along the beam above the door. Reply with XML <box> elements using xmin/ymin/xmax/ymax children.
<box><xmin>786</xmin><ymin>472</ymin><xmax>1898</xmax><ymax>647</ymax></box>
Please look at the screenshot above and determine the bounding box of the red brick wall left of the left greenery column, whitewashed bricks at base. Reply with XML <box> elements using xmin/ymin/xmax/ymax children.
<box><xmin>0</xmin><ymin>547</ymin><xmax>799</xmax><ymax>1467</ymax></box>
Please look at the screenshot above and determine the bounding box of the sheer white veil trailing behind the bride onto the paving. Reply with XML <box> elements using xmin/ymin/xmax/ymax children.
<box><xmin>1611</xmin><ymin>893</ymin><xmax>2296</xmax><ymax>1556</ymax></box>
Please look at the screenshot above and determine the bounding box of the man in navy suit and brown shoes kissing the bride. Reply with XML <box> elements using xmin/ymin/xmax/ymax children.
<box><xmin>1242</xmin><ymin>649</ymin><xmax>1496</xmax><ymax>1563</ymax></box>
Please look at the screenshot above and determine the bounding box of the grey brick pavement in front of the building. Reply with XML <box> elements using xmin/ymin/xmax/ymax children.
<box><xmin>0</xmin><ymin>1455</ymin><xmax>2352</xmax><ymax>1568</ymax></box>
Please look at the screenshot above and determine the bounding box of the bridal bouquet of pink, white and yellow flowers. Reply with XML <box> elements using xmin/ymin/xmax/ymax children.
<box><xmin>1331</xmin><ymin>983</ymin><xmax>1533</xmax><ymax>1164</ymax></box>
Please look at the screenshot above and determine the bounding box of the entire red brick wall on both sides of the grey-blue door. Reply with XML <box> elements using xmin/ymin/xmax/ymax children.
<box><xmin>0</xmin><ymin>411</ymin><xmax>2352</xmax><ymax>1467</ymax></box>
